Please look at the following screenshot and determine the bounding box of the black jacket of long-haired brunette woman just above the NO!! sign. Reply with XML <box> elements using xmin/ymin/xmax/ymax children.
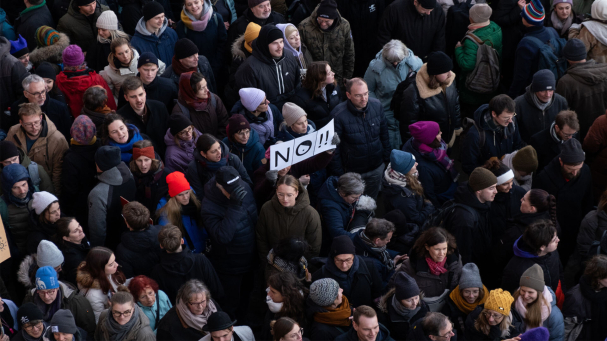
<box><xmin>291</xmin><ymin>84</ymin><xmax>340</xmax><ymax>129</ymax></box>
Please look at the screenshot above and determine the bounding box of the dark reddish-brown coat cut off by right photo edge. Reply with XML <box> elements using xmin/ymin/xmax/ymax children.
<box><xmin>583</xmin><ymin>113</ymin><xmax>607</xmax><ymax>198</ymax></box>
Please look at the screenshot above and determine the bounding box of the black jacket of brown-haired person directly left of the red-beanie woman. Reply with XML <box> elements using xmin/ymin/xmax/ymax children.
<box><xmin>116</xmin><ymin>225</ymin><xmax>162</xmax><ymax>278</ymax></box>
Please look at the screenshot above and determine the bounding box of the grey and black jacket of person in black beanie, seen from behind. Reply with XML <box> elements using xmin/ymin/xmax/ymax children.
<box><xmin>88</xmin><ymin>162</ymin><xmax>137</xmax><ymax>247</ymax></box>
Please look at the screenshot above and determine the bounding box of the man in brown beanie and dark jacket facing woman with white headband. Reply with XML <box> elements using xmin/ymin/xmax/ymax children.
<box><xmin>444</xmin><ymin>167</ymin><xmax>497</xmax><ymax>283</ymax></box>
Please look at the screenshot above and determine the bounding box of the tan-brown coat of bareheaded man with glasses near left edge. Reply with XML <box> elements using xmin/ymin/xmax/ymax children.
<box><xmin>6</xmin><ymin>115</ymin><xmax>69</xmax><ymax>196</ymax></box>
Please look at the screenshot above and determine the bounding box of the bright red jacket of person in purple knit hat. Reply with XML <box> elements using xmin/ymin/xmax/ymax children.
<box><xmin>57</xmin><ymin>69</ymin><xmax>116</xmax><ymax>118</ymax></box>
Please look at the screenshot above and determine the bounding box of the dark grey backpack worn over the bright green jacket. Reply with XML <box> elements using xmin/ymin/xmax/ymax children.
<box><xmin>464</xmin><ymin>33</ymin><xmax>500</xmax><ymax>94</ymax></box>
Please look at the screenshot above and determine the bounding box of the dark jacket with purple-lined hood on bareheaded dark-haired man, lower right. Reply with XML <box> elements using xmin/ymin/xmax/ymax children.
<box><xmin>501</xmin><ymin>237</ymin><xmax>564</xmax><ymax>293</ymax></box>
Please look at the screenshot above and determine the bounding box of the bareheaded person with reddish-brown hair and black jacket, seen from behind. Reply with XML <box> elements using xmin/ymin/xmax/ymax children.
<box><xmin>152</xmin><ymin>224</ymin><xmax>223</xmax><ymax>304</ymax></box>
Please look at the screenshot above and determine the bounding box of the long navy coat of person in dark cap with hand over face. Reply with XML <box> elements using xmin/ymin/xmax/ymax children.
<box><xmin>200</xmin><ymin>177</ymin><xmax>257</xmax><ymax>275</ymax></box>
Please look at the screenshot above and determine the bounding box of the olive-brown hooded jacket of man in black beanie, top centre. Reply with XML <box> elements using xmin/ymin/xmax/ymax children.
<box><xmin>298</xmin><ymin>4</ymin><xmax>354</xmax><ymax>84</ymax></box>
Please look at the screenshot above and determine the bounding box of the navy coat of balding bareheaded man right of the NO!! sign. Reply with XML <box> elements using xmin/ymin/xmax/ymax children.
<box><xmin>330</xmin><ymin>98</ymin><xmax>392</xmax><ymax>175</ymax></box>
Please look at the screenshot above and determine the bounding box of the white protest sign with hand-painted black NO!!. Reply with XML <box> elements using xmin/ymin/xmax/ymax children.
<box><xmin>270</xmin><ymin>120</ymin><xmax>335</xmax><ymax>170</ymax></box>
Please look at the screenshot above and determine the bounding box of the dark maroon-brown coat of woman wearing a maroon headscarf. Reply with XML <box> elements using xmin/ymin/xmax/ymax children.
<box><xmin>171</xmin><ymin>92</ymin><xmax>229</xmax><ymax>140</ymax></box>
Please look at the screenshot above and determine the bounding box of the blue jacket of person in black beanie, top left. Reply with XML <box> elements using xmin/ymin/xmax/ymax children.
<box><xmin>131</xmin><ymin>17</ymin><xmax>179</xmax><ymax>66</ymax></box>
